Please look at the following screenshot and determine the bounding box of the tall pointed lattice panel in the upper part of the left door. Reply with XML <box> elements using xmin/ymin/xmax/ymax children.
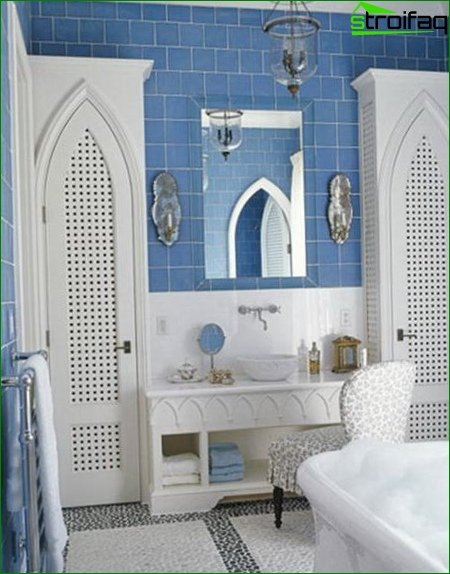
<box><xmin>64</xmin><ymin>129</ymin><xmax>119</xmax><ymax>404</ymax></box>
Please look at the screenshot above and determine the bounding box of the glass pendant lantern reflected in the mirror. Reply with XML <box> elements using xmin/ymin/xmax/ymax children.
<box><xmin>206</xmin><ymin>110</ymin><xmax>242</xmax><ymax>161</ymax></box>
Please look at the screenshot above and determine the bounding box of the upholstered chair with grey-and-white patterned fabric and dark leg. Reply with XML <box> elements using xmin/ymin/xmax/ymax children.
<box><xmin>269</xmin><ymin>361</ymin><xmax>416</xmax><ymax>528</ymax></box>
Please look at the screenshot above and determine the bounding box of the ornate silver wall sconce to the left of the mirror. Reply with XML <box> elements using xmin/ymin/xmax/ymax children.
<box><xmin>152</xmin><ymin>172</ymin><xmax>181</xmax><ymax>247</ymax></box>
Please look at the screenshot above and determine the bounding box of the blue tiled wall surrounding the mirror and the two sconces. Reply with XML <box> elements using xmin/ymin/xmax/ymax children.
<box><xmin>29</xmin><ymin>2</ymin><xmax>448</xmax><ymax>291</ymax></box>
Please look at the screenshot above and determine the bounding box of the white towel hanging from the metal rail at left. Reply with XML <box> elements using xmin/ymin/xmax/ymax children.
<box><xmin>25</xmin><ymin>354</ymin><xmax>67</xmax><ymax>572</ymax></box>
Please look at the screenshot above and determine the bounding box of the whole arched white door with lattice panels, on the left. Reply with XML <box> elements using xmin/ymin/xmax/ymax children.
<box><xmin>44</xmin><ymin>99</ymin><xmax>139</xmax><ymax>506</ymax></box>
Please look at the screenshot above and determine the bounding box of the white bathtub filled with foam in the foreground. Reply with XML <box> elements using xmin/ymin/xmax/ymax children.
<box><xmin>297</xmin><ymin>439</ymin><xmax>449</xmax><ymax>572</ymax></box>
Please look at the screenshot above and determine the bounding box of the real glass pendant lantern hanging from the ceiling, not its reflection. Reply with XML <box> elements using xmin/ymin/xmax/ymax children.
<box><xmin>262</xmin><ymin>1</ymin><xmax>320</xmax><ymax>97</ymax></box>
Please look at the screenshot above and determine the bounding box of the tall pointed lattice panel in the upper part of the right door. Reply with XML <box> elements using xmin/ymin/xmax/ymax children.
<box><xmin>406</xmin><ymin>136</ymin><xmax>448</xmax><ymax>384</ymax></box>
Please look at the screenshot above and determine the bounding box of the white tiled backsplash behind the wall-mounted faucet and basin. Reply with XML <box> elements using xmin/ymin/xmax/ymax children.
<box><xmin>147</xmin><ymin>287</ymin><xmax>364</xmax><ymax>378</ymax></box>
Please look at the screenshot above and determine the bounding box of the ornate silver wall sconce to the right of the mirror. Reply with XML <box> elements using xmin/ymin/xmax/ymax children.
<box><xmin>328</xmin><ymin>173</ymin><xmax>353</xmax><ymax>248</ymax></box>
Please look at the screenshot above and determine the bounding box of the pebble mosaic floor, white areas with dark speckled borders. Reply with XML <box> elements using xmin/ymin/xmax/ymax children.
<box><xmin>64</xmin><ymin>498</ymin><xmax>314</xmax><ymax>573</ymax></box>
